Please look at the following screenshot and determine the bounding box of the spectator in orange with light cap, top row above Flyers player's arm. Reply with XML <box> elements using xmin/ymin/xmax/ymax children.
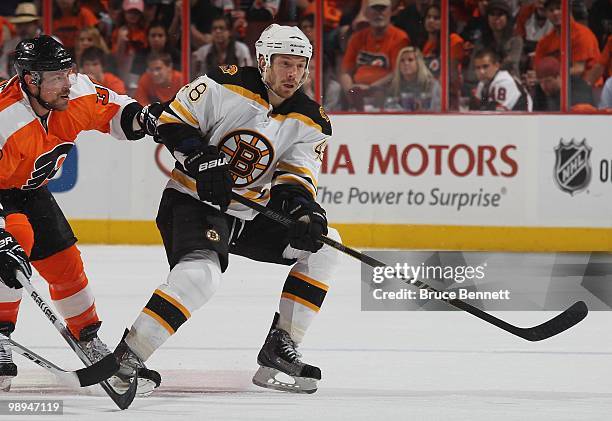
<box><xmin>112</xmin><ymin>0</ymin><xmax>147</xmax><ymax>80</ymax></box>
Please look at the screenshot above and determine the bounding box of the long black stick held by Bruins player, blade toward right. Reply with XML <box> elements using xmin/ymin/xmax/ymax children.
<box><xmin>232</xmin><ymin>192</ymin><xmax>589</xmax><ymax>342</ymax></box>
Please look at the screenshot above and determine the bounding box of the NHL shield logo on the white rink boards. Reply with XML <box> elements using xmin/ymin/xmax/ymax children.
<box><xmin>553</xmin><ymin>139</ymin><xmax>592</xmax><ymax>196</ymax></box>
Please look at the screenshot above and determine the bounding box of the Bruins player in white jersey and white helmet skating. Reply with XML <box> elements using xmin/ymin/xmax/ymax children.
<box><xmin>116</xmin><ymin>24</ymin><xmax>339</xmax><ymax>393</ymax></box>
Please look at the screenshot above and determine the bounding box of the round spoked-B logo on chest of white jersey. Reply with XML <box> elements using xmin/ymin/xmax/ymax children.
<box><xmin>219</xmin><ymin>129</ymin><xmax>274</xmax><ymax>188</ymax></box>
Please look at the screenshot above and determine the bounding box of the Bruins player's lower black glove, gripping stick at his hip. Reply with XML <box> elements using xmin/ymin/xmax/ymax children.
<box><xmin>270</xmin><ymin>184</ymin><xmax>327</xmax><ymax>253</ymax></box>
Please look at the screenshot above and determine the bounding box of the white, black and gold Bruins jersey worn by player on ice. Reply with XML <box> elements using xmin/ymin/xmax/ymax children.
<box><xmin>158</xmin><ymin>65</ymin><xmax>331</xmax><ymax>219</ymax></box>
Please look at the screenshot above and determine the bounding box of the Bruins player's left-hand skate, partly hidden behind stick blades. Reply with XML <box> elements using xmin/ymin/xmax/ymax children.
<box><xmin>108</xmin><ymin>329</ymin><xmax>161</xmax><ymax>397</ymax></box>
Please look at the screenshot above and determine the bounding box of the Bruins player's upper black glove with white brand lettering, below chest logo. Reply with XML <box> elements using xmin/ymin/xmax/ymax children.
<box><xmin>183</xmin><ymin>145</ymin><xmax>234</xmax><ymax>212</ymax></box>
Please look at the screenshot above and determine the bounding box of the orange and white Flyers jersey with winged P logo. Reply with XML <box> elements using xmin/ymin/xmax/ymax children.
<box><xmin>0</xmin><ymin>74</ymin><xmax>140</xmax><ymax>190</ymax></box>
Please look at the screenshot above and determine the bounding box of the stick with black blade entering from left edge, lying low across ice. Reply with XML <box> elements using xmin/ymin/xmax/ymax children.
<box><xmin>0</xmin><ymin>333</ymin><xmax>117</xmax><ymax>387</ymax></box>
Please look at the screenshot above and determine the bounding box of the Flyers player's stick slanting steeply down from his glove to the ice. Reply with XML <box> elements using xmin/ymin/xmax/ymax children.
<box><xmin>16</xmin><ymin>270</ymin><xmax>138</xmax><ymax>409</ymax></box>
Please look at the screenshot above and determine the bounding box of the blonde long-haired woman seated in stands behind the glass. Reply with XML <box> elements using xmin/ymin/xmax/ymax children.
<box><xmin>387</xmin><ymin>47</ymin><xmax>441</xmax><ymax>111</ymax></box>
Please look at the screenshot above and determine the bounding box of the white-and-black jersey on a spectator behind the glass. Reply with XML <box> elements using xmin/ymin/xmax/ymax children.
<box><xmin>476</xmin><ymin>70</ymin><xmax>533</xmax><ymax>111</ymax></box>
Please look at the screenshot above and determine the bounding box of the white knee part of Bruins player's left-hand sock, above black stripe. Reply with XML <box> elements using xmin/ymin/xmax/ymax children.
<box><xmin>166</xmin><ymin>250</ymin><xmax>221</xmax><ymax>312</ymax></box>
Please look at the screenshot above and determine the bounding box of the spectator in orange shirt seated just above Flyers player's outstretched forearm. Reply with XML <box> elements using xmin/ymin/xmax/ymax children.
<box><xmin>134</xmin><ymin>53</ymin><xmax>183</xmax><ymax>105</ymax></box>
